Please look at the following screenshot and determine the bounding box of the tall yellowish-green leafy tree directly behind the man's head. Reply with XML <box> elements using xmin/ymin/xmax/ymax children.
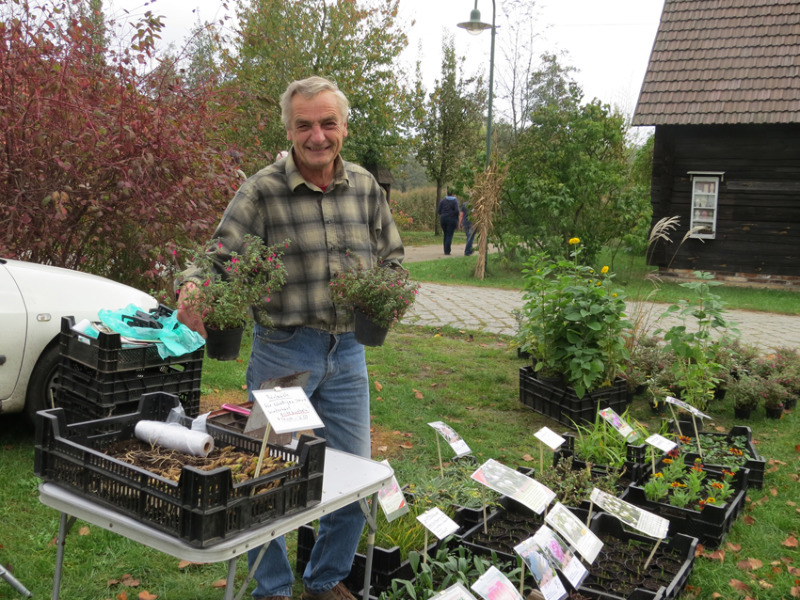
<box><xmin>228</xmin><ymin>0</ymin><xmax>410</xmax><ymax>172</ymax></box>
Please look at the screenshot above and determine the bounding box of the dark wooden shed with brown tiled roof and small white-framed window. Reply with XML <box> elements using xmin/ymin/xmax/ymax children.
<box><xmin>633</xmin><ymin>0</ymin><xmax>800</xmax><ymax>285</ymax></box>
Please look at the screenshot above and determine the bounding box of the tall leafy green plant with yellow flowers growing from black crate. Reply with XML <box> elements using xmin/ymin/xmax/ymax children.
<box><xmin>517</xmin><ymin>238</ymin><xmax>630</xmax><ymax>398</ymax></box>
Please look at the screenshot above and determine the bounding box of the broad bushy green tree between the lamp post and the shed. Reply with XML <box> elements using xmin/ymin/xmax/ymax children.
<box><xmin>496</xmin><ymin>55</ymin><xmax>641</xmax><ymax>260</ymax></box>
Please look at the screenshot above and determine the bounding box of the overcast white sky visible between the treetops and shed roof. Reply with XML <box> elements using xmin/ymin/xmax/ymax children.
<box><xmin>104</xmin><ymin>0</ymin><xmax>664</xmax><ymax>126</ymax></box>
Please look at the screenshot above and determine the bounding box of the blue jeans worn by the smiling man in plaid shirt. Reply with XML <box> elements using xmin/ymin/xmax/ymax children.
<box><xmin>247</xmin><ymin>324</ymin><xmax>370</xmax><ymax>597</ymax></box>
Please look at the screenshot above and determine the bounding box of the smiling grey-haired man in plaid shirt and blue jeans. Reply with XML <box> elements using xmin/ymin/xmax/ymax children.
<box><xmin>178</xmin><ymin>77</ymin><xmax>404</xmax><ymax>600</ymax></box>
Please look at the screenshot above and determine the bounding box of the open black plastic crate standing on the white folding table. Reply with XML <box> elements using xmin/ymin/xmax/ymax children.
<box><xmin>34</xmin><ymin>393</ymin><xmax>326</xmax><ymax>548</ymax></box>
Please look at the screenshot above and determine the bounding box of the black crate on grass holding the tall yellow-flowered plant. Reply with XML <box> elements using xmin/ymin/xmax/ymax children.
<box><xmin>519</xmin><ymin>367</ymin><xmax>628</xmax><ymax>427</ymax></box>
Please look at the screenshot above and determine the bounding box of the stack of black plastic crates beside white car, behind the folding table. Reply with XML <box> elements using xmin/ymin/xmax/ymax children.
<box><xmin>56</xmin><ymin>317</ymin><xmax>204</xmax><ymax>423</ymax></box>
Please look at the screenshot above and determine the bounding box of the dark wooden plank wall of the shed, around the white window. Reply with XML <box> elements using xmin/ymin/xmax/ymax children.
<box><xmin>649</xmin><ymin>125</ymin><xmax>800</xmax><ymax>276</ymax></box>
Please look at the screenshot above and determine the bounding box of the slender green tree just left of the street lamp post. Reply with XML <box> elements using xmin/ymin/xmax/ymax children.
<box><xmin>416</xmin><ymin>36</ymin><xmax>486</xmax><ymax>232</ymax></box>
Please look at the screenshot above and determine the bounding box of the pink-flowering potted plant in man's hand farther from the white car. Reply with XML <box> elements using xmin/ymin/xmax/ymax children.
<box><xmin>330</xmin><ymin>260</ymin><xmax>419</xmax><ymax>346</ymax></box>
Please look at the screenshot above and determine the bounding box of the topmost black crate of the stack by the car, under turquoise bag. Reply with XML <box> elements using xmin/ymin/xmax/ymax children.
<box><xmin>59</xmin><ymin>306</ymin><xmax>204</xmax><ymax>373</ymax></box>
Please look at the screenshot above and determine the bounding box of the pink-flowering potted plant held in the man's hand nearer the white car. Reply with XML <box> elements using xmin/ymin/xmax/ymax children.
<box><xmin>178</xmin><ymin>235</ymin><xmax>288</xmax><ymax>360</ymax></box>
